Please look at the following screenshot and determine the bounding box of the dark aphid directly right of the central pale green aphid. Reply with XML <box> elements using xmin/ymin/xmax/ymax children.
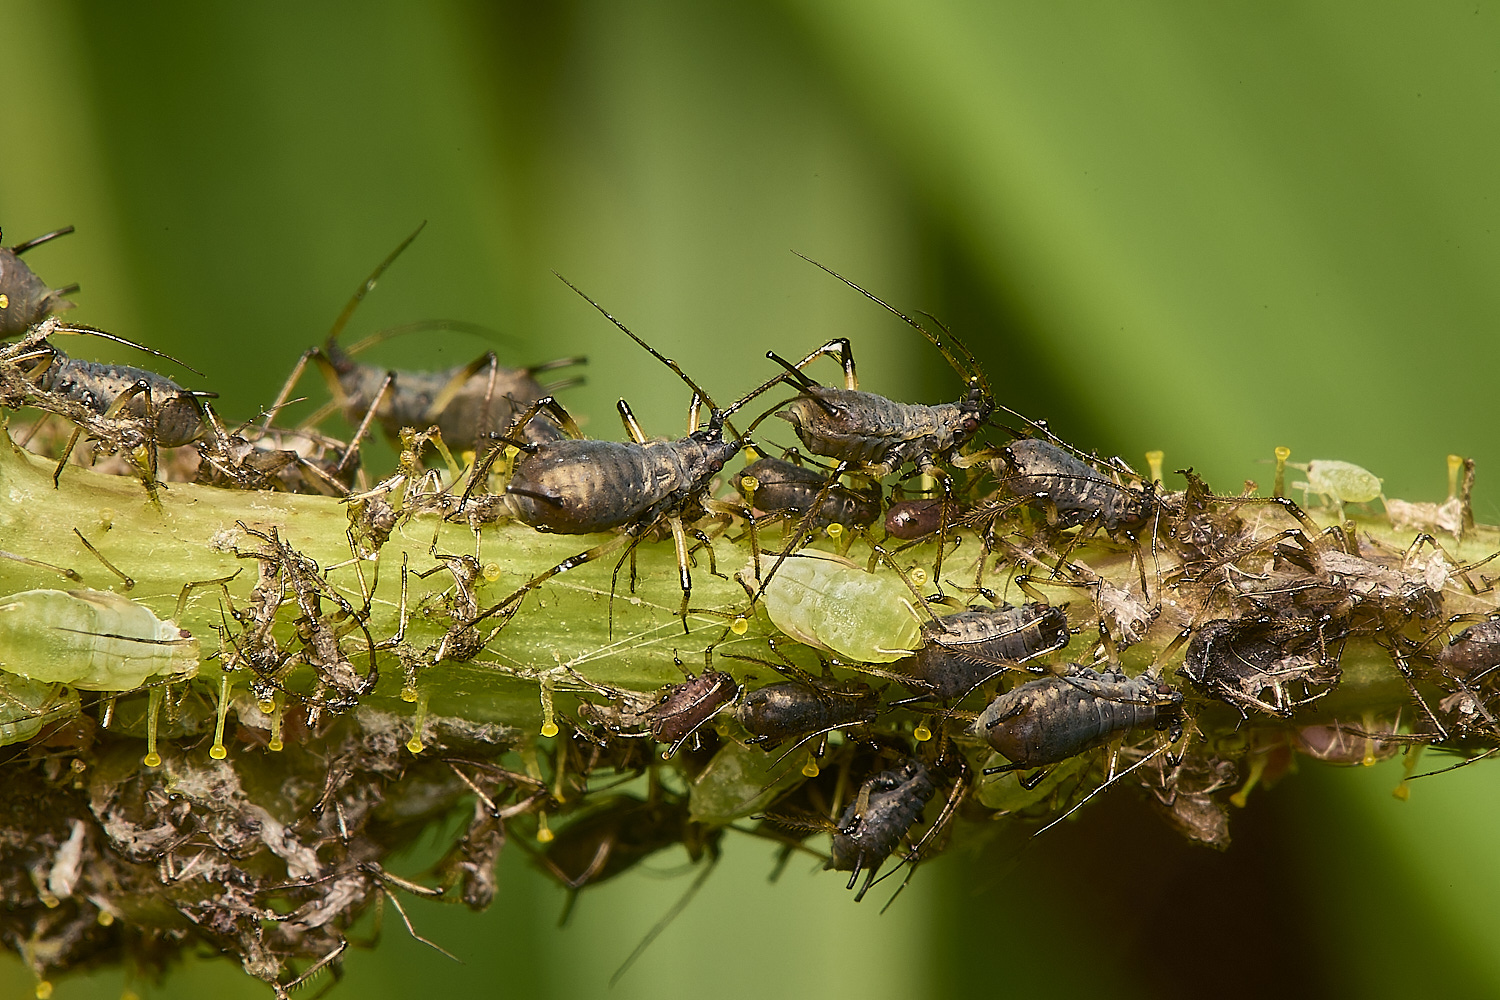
<box><xmin>905</xmin><ymin>604</ymin><xmax>1073</xmax><ymax>702</ymax></box>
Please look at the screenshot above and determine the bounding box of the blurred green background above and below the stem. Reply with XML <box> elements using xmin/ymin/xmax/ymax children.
<box><xmin>0</xmin><ymin>0</ymin><xmax>1500</xmax><ymax>1000</ymax></box>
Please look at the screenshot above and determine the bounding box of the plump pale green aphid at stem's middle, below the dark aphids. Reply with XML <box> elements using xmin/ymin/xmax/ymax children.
<box><xmin>761</xmin><ymin>552</ymin><xmax>932</xmax><ymax>663</ymax></box>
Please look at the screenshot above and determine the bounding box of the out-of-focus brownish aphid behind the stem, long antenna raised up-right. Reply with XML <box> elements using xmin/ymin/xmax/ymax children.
<box><xmin>272</xmin><ymin>222</ymin><xmax>587</xmax><ymax>451</ymax></box>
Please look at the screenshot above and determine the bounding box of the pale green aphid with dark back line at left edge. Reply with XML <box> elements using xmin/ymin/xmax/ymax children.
<box><xmin>0</xmin><ymin>591</ymin><xmax>198</xmax><ymax>691</ymax></box>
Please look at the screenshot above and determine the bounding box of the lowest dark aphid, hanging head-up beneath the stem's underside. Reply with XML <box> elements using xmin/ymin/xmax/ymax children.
<box><xmin>825</xmin><ymin>760</ymin><xmax>936</xmax><ymax>903</ymax></box>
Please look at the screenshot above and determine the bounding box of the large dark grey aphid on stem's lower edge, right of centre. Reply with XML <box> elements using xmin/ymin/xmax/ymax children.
<box><xmin>971</xmin><ymin>664</ymin><xmax>1182</xmax><ymax>774</ymax></box>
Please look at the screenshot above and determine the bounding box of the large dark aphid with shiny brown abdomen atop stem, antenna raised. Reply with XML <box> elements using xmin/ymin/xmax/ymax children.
<box><xmin>485</xmin><ymin>279</ymin><xmax>771</xmax><ymax>631</ymax></box>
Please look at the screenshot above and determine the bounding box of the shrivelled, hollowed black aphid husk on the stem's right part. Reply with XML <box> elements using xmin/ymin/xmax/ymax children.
<box><xmin>1181</xmin><ymin>615</ymin><xmax>1349</xmax><ymax>718</ymax></box>
